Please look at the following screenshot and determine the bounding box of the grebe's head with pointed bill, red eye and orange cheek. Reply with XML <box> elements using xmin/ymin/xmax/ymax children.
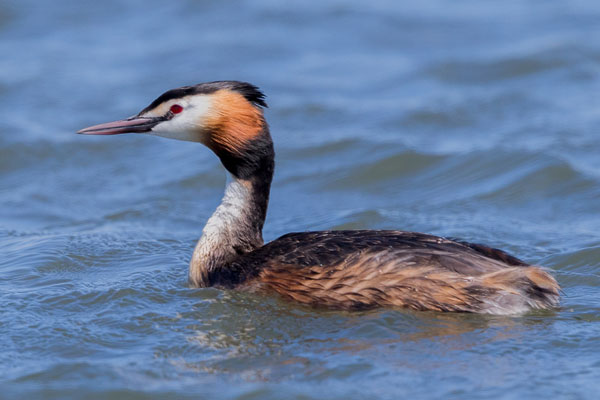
<box><xmin>77</xmin><ymin>81</ymin><xmax>274</xmax><ymax>178</ymax></box>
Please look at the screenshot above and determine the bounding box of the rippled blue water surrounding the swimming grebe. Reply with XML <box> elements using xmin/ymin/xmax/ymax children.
<box><xmin>0</xmin><ymin>0</ymin><xmax>600</xmax><ymax>399</ymax></box>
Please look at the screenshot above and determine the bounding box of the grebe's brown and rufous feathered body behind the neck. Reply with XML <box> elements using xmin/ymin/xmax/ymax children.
<box><xmin>223</xmin><ymin>231</ymin><xmax>558</xmax><ymax>314</ymax></box>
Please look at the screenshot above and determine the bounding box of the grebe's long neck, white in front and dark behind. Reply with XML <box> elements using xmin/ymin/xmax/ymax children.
<box><xmin>189</xmin><ymin>128</ymin><xmax>274</xmax><ymax>287</ymax></box>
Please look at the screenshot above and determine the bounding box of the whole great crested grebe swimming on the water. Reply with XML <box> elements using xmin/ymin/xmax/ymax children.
<box><xmin>78</xmin><ymin>81</ymin><xmax>560</xmax><ymax>314</ymax></box>
